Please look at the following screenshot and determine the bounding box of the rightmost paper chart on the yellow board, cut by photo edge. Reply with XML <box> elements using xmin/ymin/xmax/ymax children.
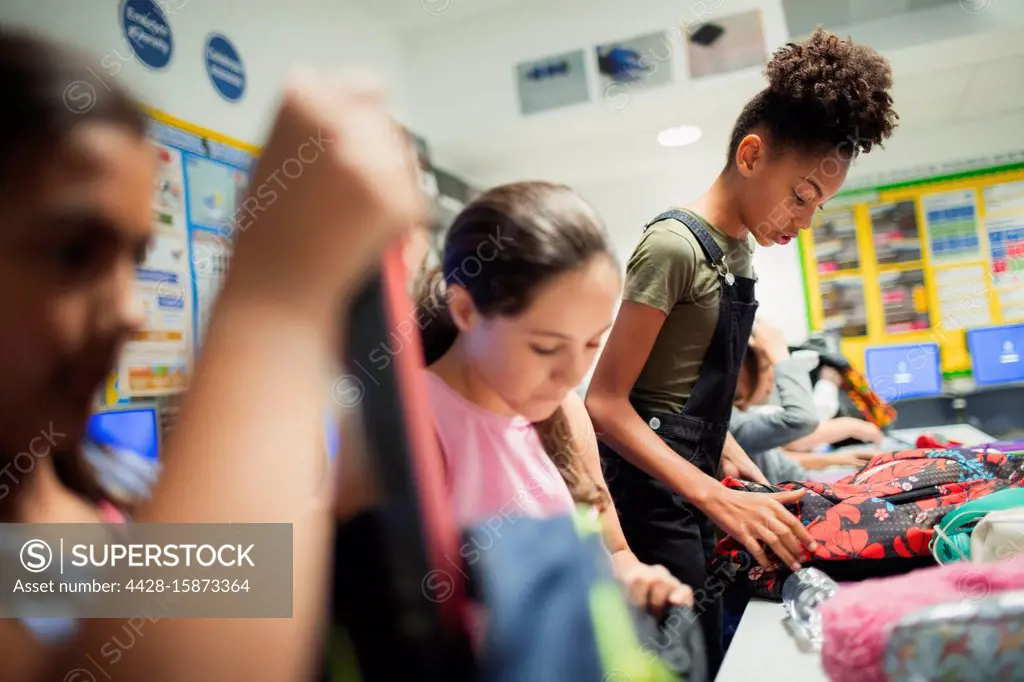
<box><xmin>983</xmin><ymin>182</ymin><xmax>1024</xmax><ymax>322</ymax></box>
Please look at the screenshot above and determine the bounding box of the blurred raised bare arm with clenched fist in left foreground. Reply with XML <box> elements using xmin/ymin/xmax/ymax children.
<box><xmin>42</xmin><ymin>73</ymin><xmax>422</xmax><ymax>682</ymax></box>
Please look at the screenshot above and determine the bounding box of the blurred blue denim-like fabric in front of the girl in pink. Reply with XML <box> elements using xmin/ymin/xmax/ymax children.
<box><xmin>463</xmin><ymin>516</ymin><xmax>614</xmax><ymax>682</ymax></box>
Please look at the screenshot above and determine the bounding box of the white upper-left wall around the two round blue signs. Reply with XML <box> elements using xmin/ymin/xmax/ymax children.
<box><xmin>0</xmin><ymin>0</ymin><xmax>413</xmax><ymax>143</ymax></box>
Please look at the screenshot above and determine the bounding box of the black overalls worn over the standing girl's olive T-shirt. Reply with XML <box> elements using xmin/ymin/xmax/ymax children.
<box><xmin>601</xmin><ymin>211</ymin><xmax>758</xmax><ymax>679</ymax></box>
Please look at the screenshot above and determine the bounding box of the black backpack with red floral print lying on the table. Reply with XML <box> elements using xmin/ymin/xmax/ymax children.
<box><xmin>711</xmin><ymin>447</ymin><xmax>1024</xmax><ymax>600</ymax></box>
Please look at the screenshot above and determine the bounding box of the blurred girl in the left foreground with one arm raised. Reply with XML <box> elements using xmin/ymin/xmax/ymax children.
<box><xmin>0</xmin><ymin>30</ymin><xmax>425</xmax><ymax>682</ymax></box>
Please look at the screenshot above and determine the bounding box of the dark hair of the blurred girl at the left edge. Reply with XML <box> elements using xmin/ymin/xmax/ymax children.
<box><xmin>0</xmin><ymin>29</ymin><xmax>145</xmax><ymax>502</ymax></box>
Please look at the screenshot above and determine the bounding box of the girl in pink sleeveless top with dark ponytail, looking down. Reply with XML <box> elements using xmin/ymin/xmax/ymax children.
<box><xmin>418</xmin><ymin>182</ymin><xmax>691</xmax><ymax>612</ymax></box>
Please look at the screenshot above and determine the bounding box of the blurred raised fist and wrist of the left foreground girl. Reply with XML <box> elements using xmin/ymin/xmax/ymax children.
<box><xmin>225</xmin><ymin>70</ymin><xmax>426</xmax><ymax>325</ymax></box>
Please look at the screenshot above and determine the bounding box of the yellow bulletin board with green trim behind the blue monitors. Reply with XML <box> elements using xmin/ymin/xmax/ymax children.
<box><xmin>798</xmin><ymin>164</ymin><xmax>1024</xmax><ymax>375</ymax></box>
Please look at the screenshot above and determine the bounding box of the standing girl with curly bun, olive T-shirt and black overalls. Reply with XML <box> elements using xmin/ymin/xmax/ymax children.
<box><xmin>587</xmin><ymin>29</ymin><xmax>897</xmax><ymax>674</ymax></box>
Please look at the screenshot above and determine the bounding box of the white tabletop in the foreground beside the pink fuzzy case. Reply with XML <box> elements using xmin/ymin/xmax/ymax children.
<box><xmin>715</xmin><ymin>598</ymin><xmax>828</xmax><ymax>682</ymax></box>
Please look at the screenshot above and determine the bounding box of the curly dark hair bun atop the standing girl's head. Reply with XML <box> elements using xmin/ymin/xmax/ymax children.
<box><xmin>765</xmin><ymin>27</ymin><xmax>899</xmax><ymax>153</ymax></box>
